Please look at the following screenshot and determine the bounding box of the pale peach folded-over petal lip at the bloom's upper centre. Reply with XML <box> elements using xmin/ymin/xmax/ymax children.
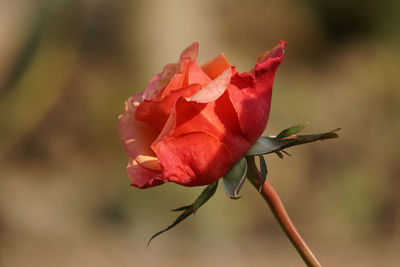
<box><xmin>187</xmin><ymin>68</ymin><xmax>232</xmax><ymax>103</ymax></box>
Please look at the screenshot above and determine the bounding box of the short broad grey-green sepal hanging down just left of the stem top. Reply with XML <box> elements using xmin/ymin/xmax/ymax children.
<box><xmin>222</xmin><ymin>157</ymin><xmax>247</xmax><ymax>199</ymax></box>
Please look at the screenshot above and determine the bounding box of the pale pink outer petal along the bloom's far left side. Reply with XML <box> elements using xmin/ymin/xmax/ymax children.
<box><xmin>118</xmin><ymin>94</ymin><xmax>158</xmax><ymax>158</ymax></box>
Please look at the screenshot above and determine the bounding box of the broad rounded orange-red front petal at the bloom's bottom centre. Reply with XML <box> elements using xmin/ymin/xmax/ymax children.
<box><xmin>156</xmin><ymin>132</ymin><xmax>235</xmax><ymax>186</ymax></box>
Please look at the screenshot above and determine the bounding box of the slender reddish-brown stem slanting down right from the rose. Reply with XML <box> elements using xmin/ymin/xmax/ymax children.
<box><xmin>246</xmin><ymin>157</ymin><xmax>321</xmax><ymax>266</ymax></box>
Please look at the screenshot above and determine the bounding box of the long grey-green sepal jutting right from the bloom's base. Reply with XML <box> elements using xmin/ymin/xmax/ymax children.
<box><xmin>246</xmin><ymin>128</ymin><xmax>340</xmax><ymax>157</ymax></box>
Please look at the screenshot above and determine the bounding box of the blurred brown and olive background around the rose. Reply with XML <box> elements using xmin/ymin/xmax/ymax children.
<box><xmin>0</xmin><ymin>0</ymin><xmax>400</xmax><ymax>266</ymax></box>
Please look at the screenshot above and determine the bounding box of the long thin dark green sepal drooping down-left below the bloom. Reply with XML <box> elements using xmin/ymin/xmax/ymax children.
<box><xmin>147</xmin><ymin>181</ymin><xmax>218</xmax><ymax>248</ymax></box>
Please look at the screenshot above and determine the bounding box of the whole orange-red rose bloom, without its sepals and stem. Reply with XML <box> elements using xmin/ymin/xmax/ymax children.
<box><xmin>118</xmin><ymin>41</ymin><xmax>285</xmax><ymax>188</ymax></box>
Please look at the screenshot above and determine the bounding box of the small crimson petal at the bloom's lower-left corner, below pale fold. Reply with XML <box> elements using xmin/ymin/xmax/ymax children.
<box><xmin>127</xmin><ymin>158</ymin><xmax>166</xmax><ymax>188</ymax></box>
